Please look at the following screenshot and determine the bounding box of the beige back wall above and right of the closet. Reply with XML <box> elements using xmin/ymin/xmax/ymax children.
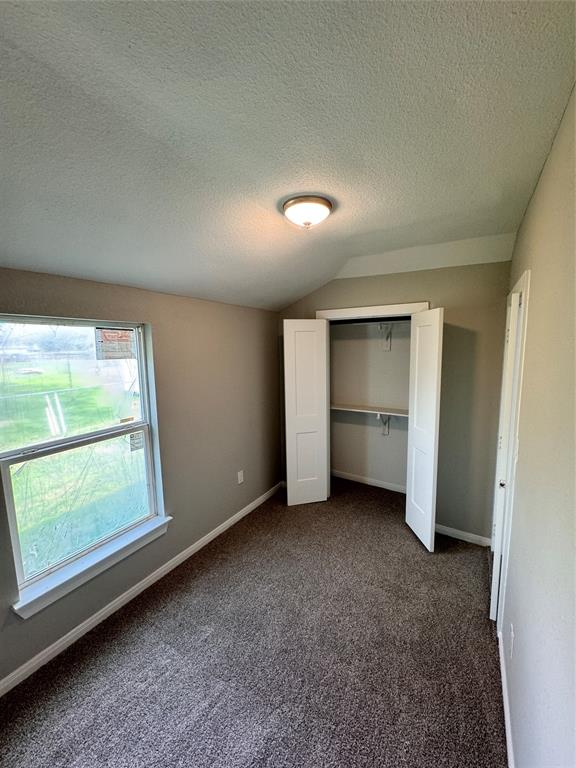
<box><xmin>282</xmin><ymin>262</ymin><xmax>510</xmax><ymax>536</ymax></box>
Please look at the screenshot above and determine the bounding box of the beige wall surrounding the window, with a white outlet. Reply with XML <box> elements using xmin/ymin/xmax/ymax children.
<box><xmin>0</xmin><ymin>270</ymin><xmax>279</xmax><ymax>678</ymax></box>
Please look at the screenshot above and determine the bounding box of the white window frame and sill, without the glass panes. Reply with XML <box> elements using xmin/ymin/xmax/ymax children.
<box><xmin>0</xmin><ymin>314</ymin><xmax>172</xmax><ymax>618</ymax></box>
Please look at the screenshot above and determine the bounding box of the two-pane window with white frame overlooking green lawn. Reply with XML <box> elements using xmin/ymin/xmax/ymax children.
<box><xmin>0</xmin><ymin>317</ymin><xmax>169</xmax><ymax>607</ymax></box>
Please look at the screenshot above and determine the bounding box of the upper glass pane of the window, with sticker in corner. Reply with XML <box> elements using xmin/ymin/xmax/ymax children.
<box><xmin>0</xmin><ymin>321</ymin><xmax>142</xmax><ymax>451</ymax></box>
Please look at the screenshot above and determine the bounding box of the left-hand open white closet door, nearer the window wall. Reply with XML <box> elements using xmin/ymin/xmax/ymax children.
<box><xmin>284</xmin><ymin>320</ymin><xmax>330</xmax><ymax>505</ymax></box>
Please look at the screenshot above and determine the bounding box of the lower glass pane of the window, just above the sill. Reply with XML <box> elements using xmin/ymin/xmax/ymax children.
<box><xmin>10</xmin><ymin>432</ymin><xmax>151</xmax><ymax>579</ymax></box>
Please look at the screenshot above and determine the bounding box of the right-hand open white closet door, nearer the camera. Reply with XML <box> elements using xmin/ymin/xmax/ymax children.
<box><xmin>406</xmin><ymin>308</ymin><xmax>444</xmax><ymax>552</ymax></box>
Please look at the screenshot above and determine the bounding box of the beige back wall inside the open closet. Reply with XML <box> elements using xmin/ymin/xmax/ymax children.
<box><xmin>330</xmin><ymin>319</ymin><xmax>410</xmax><ymax>492</ymax></box>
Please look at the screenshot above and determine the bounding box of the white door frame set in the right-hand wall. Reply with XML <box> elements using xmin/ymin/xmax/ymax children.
<box><xmin>490</xmin><ymin>270</ymin><xmax>530</xmax><ymax>631</ymax></box>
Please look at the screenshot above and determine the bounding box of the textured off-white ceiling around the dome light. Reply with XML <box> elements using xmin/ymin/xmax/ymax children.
<box><xmin>0</xmin><ymin>0</ymin><xmax>574</xmax><ymax>308</ymax></box>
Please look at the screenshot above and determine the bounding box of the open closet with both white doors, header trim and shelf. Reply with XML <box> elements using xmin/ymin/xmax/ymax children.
<box><xmin>284</xmin><ymin>302</ymin><xmax>444</xmax><ymax>552</ymax></box>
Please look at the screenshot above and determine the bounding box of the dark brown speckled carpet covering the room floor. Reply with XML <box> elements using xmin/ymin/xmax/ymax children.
<box><xmin>0</xmin><ymin>481</ymin><xmax>506</xmax><ymax>768</ymax></box>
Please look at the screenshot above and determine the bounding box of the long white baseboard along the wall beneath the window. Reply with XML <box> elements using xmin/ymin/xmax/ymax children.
<box><xmin>0</xmin><ymin>483</ymin><xmax>282</xmax><ymax>696</ymax></box>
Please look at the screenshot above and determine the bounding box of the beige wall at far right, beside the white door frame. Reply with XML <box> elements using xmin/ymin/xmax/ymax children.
<box><xmin>503</xmin><ymin>88</ymin><xmax>576</xmax><ymax>768</ymax></box>
